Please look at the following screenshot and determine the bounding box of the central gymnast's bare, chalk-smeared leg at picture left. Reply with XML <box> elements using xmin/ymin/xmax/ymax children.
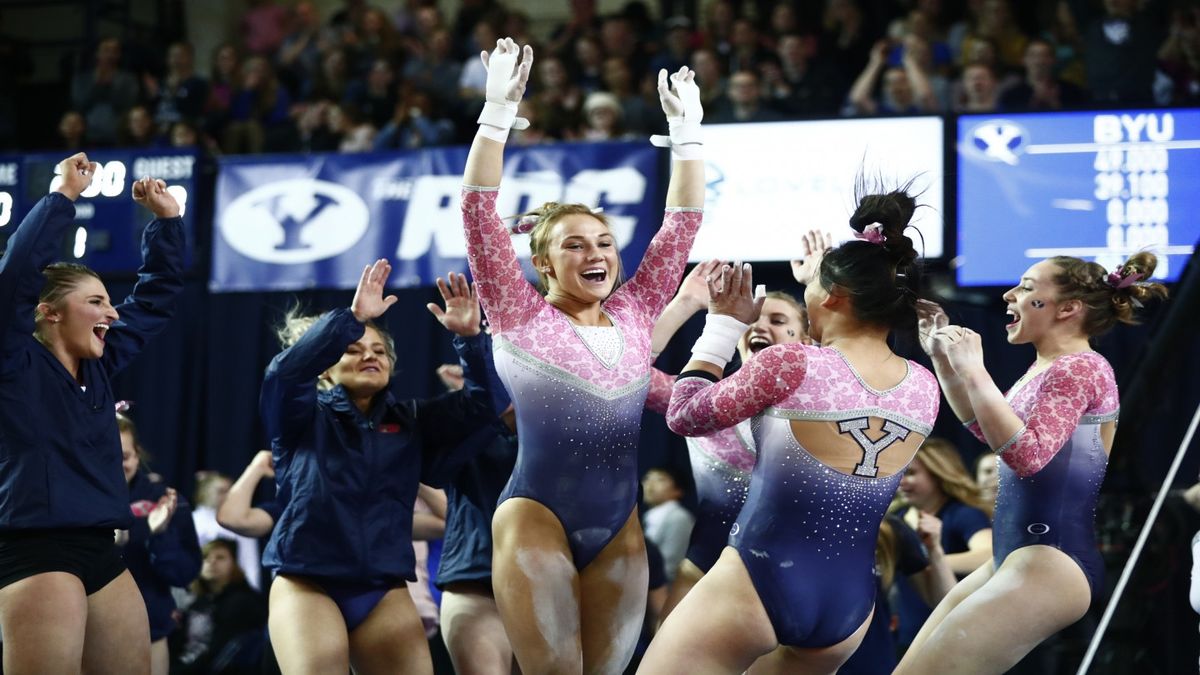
<box><xmin>492</xmin><ymin>497</ymin><xmax>583</xmax><ymax>675</ymax></box>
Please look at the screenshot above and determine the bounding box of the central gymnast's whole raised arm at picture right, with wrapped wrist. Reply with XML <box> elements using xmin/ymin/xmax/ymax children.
<box><xmin>624</xmin><ymin>66</ymin><xmax>704</xmax><ymax>317</ymax></box>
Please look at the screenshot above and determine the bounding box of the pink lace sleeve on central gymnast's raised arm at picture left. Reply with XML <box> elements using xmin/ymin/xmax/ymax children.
<box><xmin>462</xmin><ymin>186</ymin><xmax>541</xmax><ymax>333</ymax></box>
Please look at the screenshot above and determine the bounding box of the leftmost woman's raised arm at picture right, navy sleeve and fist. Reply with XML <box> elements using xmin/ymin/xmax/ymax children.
<box><xmin>101</xmin><ymin>178</ymin><xmax>186</xmax><ymax>374</ymax></box>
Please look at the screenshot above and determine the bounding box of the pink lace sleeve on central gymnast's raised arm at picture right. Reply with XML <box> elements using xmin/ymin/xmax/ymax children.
<box><xmin>625</xmin><ymin>207</ymin><xmax>704</xmax><ymax>318</ymax></box>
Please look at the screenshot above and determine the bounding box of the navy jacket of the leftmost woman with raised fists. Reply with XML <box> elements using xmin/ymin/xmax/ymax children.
<box><xmin>0</xmin><ymin>192</ymin><xmax>184</xmax><ymax>531</ymax></box>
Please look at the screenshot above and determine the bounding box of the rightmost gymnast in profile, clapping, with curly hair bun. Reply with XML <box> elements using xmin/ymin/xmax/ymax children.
<box><xmin>896</xmin><ymin>252</ymin><xmax>1166</xmax><ymax>674</ymax></box>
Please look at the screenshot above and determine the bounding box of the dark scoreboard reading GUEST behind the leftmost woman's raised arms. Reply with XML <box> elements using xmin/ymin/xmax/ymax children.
<box><xmin>0</xmin><ymin>149</ymin><xmax>198</xmax><ymax>274</ymax></box>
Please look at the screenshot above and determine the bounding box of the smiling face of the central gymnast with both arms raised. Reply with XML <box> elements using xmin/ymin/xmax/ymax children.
<box><xmin>533</xmin><ymin>214</ymin><xmax>620</xmax><ymax>304</ymax></box>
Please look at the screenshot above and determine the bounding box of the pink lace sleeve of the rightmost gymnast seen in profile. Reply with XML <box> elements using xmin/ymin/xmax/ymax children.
<box><xmin>996</xmin><ymin>354</ymin><xmax>1116</xmax><ymax>477</ymax></box>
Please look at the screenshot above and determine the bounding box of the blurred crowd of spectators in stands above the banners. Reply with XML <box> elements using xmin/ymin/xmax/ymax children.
<box><xmin>35</xmin><ymin>0</ymin><xmax>1200</xmax><ymax>154</ymax></box>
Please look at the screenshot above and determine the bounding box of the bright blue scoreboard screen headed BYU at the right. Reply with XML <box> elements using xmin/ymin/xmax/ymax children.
<box><xmin>956</xmin><ymin>109</ymin><xmax>1200</xmax><ymax>286</ymax></box>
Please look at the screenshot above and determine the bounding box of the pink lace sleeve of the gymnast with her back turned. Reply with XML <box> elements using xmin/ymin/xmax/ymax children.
<box><xmin>667</xmin><ymin>345</ymin><xmax>808</xmax><ymax>436</ymax></box>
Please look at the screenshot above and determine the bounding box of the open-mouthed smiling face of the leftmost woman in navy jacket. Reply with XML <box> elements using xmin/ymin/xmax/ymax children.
<box><xmin>38</xmin><ymin>275</ymin><xmax>118</xmax><ymax>359</ymax></box>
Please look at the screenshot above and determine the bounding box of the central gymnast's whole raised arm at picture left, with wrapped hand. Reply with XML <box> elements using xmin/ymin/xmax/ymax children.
<box><xmin>462</xmin><ymin>38</ymin><xmax>540</xmax><ymax>333</ymax></box>
